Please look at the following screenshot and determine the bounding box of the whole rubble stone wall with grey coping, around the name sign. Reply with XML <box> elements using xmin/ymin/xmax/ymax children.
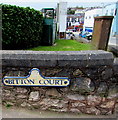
<box><xmin>2</xmin><ymin>50</ymin><xmax>118</xmax><ymax>115</ymax></box>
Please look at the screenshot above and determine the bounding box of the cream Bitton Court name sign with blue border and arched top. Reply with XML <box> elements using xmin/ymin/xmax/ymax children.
<box><xmin>3</xmin><ymin>68</ymin><xmax>70</xmax><ymax>87</ymax></box>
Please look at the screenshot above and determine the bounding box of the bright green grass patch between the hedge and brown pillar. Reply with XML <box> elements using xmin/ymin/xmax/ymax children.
<box><xmin>28</xmin><ymin>40</ymin><xmax>91</xmax><ymax>51</ymax></box>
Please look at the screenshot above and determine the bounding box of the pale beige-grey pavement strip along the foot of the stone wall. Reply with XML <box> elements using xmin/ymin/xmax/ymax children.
<box><xmin>2</xmin><ymin>106</ymin><xmax>116</xmax><ymax>120</ymax></box>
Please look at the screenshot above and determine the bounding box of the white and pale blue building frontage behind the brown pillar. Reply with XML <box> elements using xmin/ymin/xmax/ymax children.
<box><xmin>83</xmin><ymin>2</ymin><xmax>118</xmax><ymax>36</ymax></box>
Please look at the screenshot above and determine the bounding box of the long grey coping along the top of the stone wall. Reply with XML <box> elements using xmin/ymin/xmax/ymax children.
<box><xmin>0</xmin><ymin>50</ymin><xmax>114</xmax><ymax>67</ymax></box>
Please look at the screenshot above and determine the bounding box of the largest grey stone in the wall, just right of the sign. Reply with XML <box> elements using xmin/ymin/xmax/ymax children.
<box><xmin>71</xmin><ymin>77</ymin><xmax>92</xmax><ymax>94</ymax></box>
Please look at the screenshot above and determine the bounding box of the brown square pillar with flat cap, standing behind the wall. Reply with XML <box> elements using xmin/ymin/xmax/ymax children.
<box><xmin>92</xmin><ymin>16</ymin><xmax>113</xmax><ymax>50</ymax></box>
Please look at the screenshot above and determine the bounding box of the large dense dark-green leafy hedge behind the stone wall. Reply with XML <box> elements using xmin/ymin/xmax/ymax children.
<box><xmin>2</xmin><ymin>4</ymin><xmax>43</xmax><ymax>50</ymax></box>
